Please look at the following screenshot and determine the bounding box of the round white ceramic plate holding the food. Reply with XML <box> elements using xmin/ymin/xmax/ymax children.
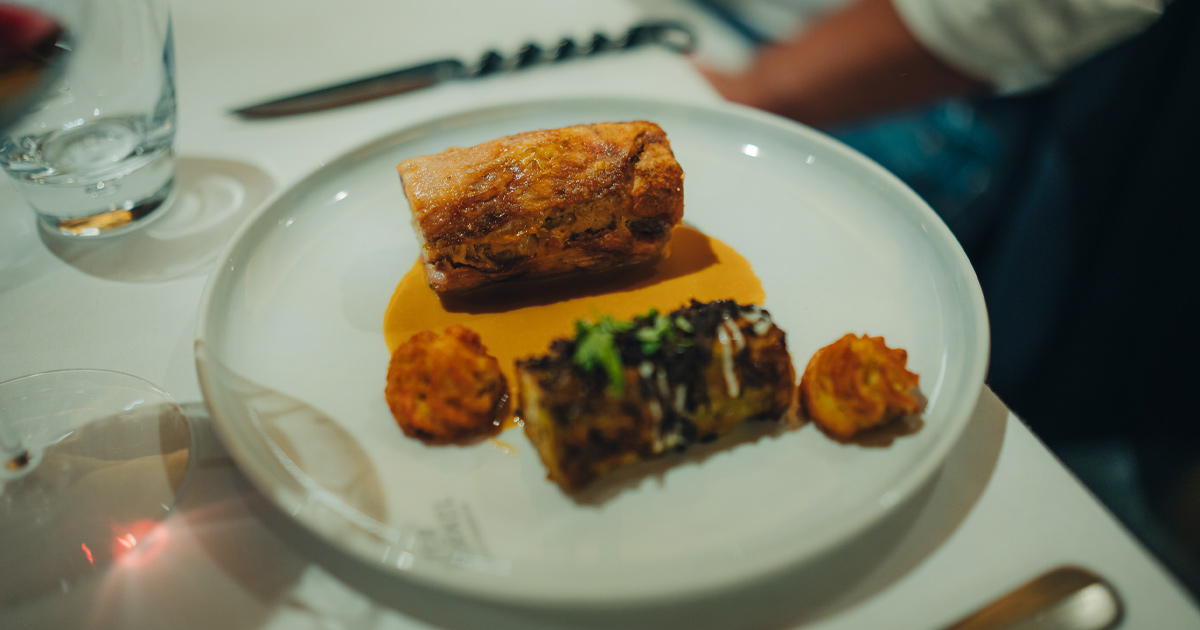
<box><xmin>197</xmin><ymin>98</ymin><xmax>989</xmax><ymax>604</ymax></box>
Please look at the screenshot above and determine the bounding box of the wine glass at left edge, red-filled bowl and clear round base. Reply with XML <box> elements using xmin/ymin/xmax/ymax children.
<box><xmin>0</xmin><ymin>0</ymin><xmax>192</xmax><ymax>606</ymax></box>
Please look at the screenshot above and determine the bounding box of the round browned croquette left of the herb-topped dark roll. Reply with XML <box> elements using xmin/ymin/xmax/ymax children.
<box><xmin>384</xmin><ymin>324</ymin><xmax>509</xmax><ymax>444</ymax></box>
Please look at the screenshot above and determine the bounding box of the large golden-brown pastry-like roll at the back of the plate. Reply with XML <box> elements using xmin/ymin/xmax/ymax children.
<box><xmin>396</xmin><ymin>121</ymin><xmax>683</xmax><ymax>293</ymax></box>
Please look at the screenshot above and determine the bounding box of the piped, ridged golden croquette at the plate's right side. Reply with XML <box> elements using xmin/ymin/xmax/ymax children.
<box><xmin>800</xmin><ymin>334</ymin><xmax>920</xmax><ymax>439</ymax></box>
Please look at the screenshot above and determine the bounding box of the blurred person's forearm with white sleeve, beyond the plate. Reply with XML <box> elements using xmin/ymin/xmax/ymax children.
<box><xmin>703</xmin><ymin>0</ymin><xmax>1170</xmax><ymax>126</ymax></box>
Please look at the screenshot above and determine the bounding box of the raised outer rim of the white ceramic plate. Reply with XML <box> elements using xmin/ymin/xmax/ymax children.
<box><xmin>194</xmin><ymin>95</ymin><xmax>990</xmax><ymax>606</ymax></box>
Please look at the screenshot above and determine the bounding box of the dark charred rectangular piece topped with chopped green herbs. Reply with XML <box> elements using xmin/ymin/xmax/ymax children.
<box><xmin>516</xmin><ymin>300</ymin><xmax>796</xmax><ymax>491</ymax></box>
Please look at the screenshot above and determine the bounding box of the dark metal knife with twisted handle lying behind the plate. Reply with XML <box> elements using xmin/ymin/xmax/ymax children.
<box><xmin>230</xmin><ymin>22</ymin><xmax>696</xmax><ymax>120</ymax></box>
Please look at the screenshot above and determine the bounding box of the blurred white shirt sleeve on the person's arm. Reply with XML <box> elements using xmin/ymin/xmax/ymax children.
<box><xmin>892</xmin><ymin>0</ymin><xmax>1171</xmax><ymax>92</ymax></box>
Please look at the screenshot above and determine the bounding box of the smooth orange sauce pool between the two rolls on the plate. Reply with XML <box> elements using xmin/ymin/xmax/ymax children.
<box><xmin>383</xmin><ymin>227</ymin><xmax>766</xmax><ymax>420</ymax></box>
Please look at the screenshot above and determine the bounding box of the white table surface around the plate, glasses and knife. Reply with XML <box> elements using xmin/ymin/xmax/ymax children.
<box><xmin>0</xmin><ymin>0</ymin><xmax>1200</xmax><ymax>629</ymax></box>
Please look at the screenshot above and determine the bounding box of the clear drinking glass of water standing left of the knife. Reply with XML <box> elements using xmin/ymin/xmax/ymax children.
<box><xmin>0</xmin><ymin>0</ymin><xmax>175</xmax><ymax>238</ymax></box>
